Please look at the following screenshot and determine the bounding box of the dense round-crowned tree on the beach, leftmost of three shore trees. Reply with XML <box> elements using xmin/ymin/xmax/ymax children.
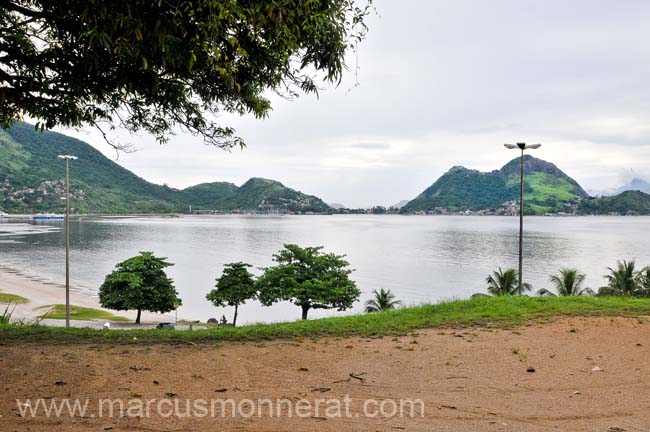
<box><xmin>99</xmin><ymin>252</ymin><xmax>182</xmax><ymax>324</ymax></box>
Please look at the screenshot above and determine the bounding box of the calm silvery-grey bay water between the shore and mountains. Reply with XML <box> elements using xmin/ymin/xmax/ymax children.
<box><xmin>0</xmin><ymin>215</ymin><xmax>650</xmax><ymax>322</ymax></box>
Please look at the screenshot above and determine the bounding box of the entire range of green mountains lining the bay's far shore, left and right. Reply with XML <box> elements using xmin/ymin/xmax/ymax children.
<box><xmin>0</xmin><ymin>123</ymin><xmax>650</xmax><ymax>214</ymax></box>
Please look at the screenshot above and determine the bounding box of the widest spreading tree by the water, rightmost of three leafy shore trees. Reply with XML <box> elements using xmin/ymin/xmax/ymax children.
<box><xmin>257</xmin><ymin>244</ymin><xmax>361</xmax><ymax>320</ymax></box>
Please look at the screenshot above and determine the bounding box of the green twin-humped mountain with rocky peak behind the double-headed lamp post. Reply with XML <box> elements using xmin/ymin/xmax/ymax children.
<box><xmin>402</xmin><ymin>155</ymin><xmax>589</xmax><ymax>213</ymax></box>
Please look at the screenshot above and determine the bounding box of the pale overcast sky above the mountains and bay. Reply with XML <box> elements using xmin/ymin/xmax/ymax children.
<box><xmin>59</xmin><ymin>0</ymin><xmax>650</xmax><ymax>207</ymax></box>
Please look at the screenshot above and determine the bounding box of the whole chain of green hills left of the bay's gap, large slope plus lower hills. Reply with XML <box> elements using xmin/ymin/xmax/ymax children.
<box><xmin>0</xmin><ymin>123</ymin><xmax>331</xmax><ymax>214</ymax></box>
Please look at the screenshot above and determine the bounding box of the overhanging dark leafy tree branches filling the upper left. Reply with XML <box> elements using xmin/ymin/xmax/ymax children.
<box><xmin>0</xmin><ymin>0</ymin><xmax>372</xmax><ymax>148</ymax></box>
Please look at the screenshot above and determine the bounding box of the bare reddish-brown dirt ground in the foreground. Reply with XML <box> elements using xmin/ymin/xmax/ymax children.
<box><xmin>0</xmin><ymin>318</ymin><xmax>650</xmax><ymax>432</ymax></box>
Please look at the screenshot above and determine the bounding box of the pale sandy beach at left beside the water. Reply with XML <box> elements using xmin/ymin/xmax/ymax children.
<box><xmin>0</xmin><ymin>268</ymin><xmax>174</xmax><ymax>327</ymax></box>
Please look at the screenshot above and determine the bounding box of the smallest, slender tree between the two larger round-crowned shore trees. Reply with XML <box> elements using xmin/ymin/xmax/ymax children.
<box><xmin>206</xmin><ymin>262</ymin><xmax>257</xmax><ymax>325</ymax></box>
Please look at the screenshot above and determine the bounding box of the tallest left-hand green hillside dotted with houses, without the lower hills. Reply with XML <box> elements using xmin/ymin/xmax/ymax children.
<box><xmin>0</xmin><ymin>123</ymin><xmax>182</xmax><ymax>213</ymax></box>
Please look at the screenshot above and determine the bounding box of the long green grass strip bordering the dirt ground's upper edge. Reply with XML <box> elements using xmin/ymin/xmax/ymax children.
<box><xmin>0</xmin><ymin>296</ymin><xmax>650</xmax><ymax>343</ymax></box>
